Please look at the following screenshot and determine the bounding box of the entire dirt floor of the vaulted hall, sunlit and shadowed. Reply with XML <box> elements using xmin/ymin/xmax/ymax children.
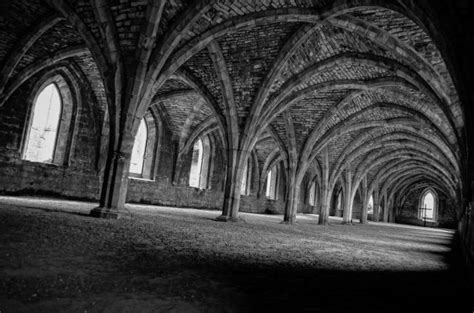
<box><xmin>0</xmin><ymin>197</ymin><xmax>473</xmax><ymax>313</ymax></box>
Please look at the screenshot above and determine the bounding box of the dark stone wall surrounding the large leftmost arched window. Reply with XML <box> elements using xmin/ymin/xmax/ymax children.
<box><xmin>0</xmin><ymin>69</ymin><xmax>100</xmax><ymax>200</ymax></box>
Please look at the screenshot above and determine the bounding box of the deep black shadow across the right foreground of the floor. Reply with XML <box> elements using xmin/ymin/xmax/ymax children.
<box><xmin>117</xmin><ymin>233</ymin><xmax>473</xmax><ymax>313</ymax></box>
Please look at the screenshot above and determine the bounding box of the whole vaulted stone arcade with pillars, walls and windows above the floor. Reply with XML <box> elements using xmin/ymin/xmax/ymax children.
<box><xmin>0</xmin><ymin>0</ymin><xmax>474</xmax><ymax>300</ymax></box>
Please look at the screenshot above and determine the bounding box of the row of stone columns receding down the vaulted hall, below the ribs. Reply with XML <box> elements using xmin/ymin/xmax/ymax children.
<box><xmin>91</xmin><ymin>132</ymin><xmax>393</xmax><ymax>225</ymax></box>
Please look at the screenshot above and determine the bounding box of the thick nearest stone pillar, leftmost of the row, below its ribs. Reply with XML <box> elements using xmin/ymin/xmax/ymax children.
<box><xmin>90</xmin><ymin>130</ymin><xmax>133</xmax><ymax>218</ymax></box>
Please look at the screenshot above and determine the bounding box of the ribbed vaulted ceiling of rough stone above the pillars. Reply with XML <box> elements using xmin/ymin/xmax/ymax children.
<box><xmin>0</xmin><ymin>0</ymin><xmax>465</xmax><ymax>202</ymax></box>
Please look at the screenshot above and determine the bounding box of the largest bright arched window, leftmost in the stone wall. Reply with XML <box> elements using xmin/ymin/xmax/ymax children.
<box><xmin>23</xmin><ymin>83</ymin><xmax>62</xmax><ymax>163</ymax></box>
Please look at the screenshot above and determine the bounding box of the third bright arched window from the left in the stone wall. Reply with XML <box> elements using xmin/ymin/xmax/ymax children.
<box><xmin>189</xmin><ymin>136</ymin><xmax>211</xmax><ymax>189</ymax></box>
